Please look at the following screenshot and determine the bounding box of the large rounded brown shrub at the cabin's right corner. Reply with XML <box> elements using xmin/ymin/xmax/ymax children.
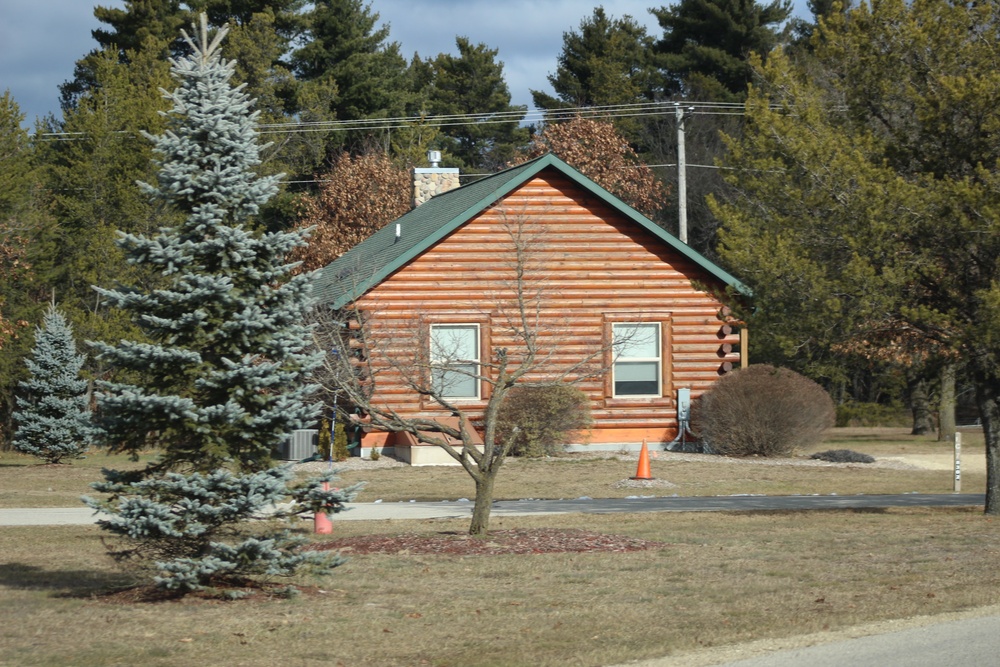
<box><xmin>692</xmin><ymin>365</ymin><xmax>835</xmax><ymax>456</ymax></box>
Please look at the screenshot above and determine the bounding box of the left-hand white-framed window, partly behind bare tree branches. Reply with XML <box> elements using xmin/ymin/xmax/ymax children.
<box><xmin>430</xmin><ymin>324</ymin><xmax>480</xmax><ymax>400</ymax></box>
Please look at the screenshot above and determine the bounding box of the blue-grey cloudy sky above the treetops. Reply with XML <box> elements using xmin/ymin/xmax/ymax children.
<box><xmin>0</xmin><ymin>0</ymin><xmax>805</xmax><ymax>126</ymax></box>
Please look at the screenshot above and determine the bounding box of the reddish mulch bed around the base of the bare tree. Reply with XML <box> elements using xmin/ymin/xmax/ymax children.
<box><xmin>311</xmin><ymin>528</ymin><xmax>667</xmax><ymax>556</ymax></box>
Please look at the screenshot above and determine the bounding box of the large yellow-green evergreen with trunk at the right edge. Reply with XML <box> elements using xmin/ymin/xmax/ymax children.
<box><xmin>718</xmin><ymin>0</ymin><xmax>1000</xmax><ymax>514</ymax></box>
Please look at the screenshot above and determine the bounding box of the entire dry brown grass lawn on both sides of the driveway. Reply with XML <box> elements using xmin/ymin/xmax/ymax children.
<box><xmin>0</xmin><ymin>429</ymin><xmax>1000</xmax><ymax>667</ymax></box>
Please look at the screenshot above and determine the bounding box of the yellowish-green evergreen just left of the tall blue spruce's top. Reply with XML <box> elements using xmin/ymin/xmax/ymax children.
<box><xmin>32</xmin><ymin>43</ymin><xmax>170</xmax><ymax>350</ymax></box>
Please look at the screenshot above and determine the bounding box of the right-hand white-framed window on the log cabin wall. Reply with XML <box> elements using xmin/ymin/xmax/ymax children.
<box><xmin>611</xmin><ymin>322</ymin><xmax>663</xmax><ymax>398</ymax></box>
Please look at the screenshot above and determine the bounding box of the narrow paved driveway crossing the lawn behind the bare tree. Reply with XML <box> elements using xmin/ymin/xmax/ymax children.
<box><xmin>0</xmin><ymin>493</ymin><xmax>985</xmax><ymax>526</ymax></box>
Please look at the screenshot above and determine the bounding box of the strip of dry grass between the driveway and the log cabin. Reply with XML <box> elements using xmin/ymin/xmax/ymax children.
<box><xmin>0</xmin><ymin>429</ymin><xmax>986</xmax><ymax>507</ymax></box>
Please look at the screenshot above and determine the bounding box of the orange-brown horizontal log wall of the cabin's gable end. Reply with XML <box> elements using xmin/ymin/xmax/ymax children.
<box><xmin>358</xmin><ymin>171</ymin><xmax>739</xmax><ymax>442</ymax></box>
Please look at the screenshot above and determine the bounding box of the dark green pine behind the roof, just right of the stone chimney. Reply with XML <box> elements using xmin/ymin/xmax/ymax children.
<box><xmin>427</xmin><ymin>37</ymin><xmax>528</xmax><ymax>171</ymax></box>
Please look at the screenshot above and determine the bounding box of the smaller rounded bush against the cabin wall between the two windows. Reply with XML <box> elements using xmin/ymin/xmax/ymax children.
<box><xmin>497</xmin><ymin>384</ymin><xmax>593</xmax><ymax>457</ymax></box>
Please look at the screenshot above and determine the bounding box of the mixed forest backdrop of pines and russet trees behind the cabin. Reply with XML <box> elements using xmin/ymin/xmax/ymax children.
<box><xmin>0</xmin><ymin>0</ymin><xmax>975</xmax><ymax>454</ymax></box>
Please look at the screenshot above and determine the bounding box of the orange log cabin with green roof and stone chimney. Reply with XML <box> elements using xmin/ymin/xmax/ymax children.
<box><xmin>314</xmin><ymin>154</ymin><xmax>746</xmax><ymax>464</ymax></box>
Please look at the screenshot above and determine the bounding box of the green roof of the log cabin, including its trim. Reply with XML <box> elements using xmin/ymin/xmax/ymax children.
<box><xmin>313</xmin><ymin>153</ymin><xmax>750</xmax><ymax>309</ymax></box>
